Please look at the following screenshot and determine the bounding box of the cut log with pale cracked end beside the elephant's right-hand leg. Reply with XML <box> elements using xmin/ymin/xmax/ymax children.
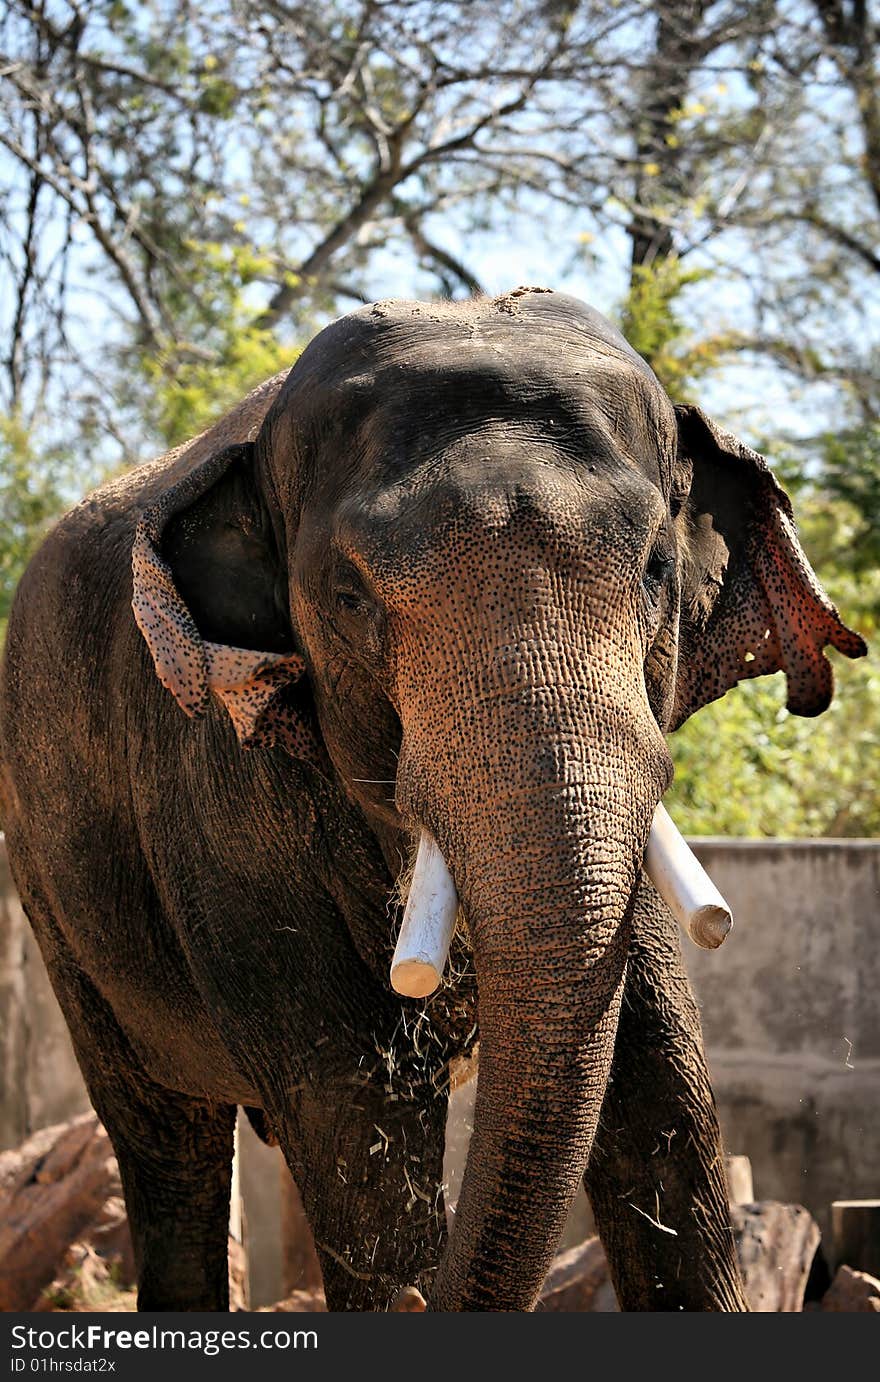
<box><xmin>731</xmin><ymin>1200</ymin><xmax>821</xmax><ymax>1314</ymax></box>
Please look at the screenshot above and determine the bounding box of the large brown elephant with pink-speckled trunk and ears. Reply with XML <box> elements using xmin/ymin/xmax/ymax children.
<box><xmin>1</xmin><ymin>287</ymin><xmax>865</xmax><ymax>1312</ymax></box>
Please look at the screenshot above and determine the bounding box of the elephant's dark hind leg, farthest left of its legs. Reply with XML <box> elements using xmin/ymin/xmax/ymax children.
<box><xmin>42</xmin><ymin>966</ymin><xmax>236</xmax><ymax>1310</ymax></box>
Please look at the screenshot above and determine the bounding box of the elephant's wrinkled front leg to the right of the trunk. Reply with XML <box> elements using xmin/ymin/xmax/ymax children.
<box><xmin>584</xmin><ymin>880</ymin><xmax>749</xmax><ymax>1312</ymax></box>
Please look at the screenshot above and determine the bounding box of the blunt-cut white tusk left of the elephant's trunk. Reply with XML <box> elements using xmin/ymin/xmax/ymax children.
<box><xmin>391</xmin><ymin>831</ymin><xmax>459</xmax><ymax>998</ymax></box>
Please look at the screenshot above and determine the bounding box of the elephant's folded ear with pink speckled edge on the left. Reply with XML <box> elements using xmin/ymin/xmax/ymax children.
<box><xmin>131</xmin><ymin>444</ymin><xmax>323</xmax><ymax>764</ymax></box>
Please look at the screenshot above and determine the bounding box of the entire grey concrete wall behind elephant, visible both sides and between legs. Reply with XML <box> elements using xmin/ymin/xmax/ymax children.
<box><xmin>0</xmin><ymin>836</ymin><xmax>880</xmax><ymax>1305</ymax></box>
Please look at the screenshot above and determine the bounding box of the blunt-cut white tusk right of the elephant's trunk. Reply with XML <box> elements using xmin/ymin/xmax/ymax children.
<box><xmin>645</xmin><ymin>802</ymin><xmax>734</xmax><ymax>949</ymax></box>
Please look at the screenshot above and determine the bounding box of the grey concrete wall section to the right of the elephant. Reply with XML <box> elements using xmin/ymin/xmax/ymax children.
<box><xmin>684</xmin><ymin>839</ymin><xmax>880</xmax><ymax>1230</ymax></box>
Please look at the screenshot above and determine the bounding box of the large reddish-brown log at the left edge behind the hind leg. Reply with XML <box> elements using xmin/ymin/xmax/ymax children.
<box><xmin>0</xmin><ymin>1114</ymin><xmax>119</xmax><ymax>1310</ymax></box>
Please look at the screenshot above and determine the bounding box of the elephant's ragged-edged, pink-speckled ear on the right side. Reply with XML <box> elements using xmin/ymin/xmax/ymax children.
<box><xmin>670</xmin><ymin>405</ymin><xmax>868</xmax><ymax>730</ymax></box>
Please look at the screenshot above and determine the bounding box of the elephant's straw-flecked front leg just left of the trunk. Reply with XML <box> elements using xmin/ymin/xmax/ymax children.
<box><xmin>279</xmin><ymin>1061</ymin><xmax>448</xmax><ymax>1310</ymax></box>
